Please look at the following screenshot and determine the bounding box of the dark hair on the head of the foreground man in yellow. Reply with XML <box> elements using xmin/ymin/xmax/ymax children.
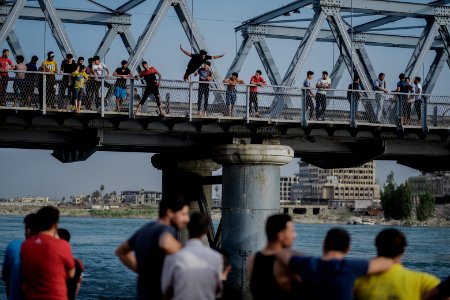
<box><xmin>375</xmin><ymin>228</ymin><xmax>408</xmax><ymax>258</ymax></box>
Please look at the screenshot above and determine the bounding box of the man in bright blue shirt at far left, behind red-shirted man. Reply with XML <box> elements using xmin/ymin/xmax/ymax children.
<box><xmin>2</xmin><ymin>214</ymin><xmax>38</xmax><ymax>300</ymax></box>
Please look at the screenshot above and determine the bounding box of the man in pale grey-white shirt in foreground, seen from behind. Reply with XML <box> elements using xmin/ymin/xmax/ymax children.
<box><xmin>161</xmin><ymin>213</ymin><xmax>223</xmax><ymax>300</ymax></box>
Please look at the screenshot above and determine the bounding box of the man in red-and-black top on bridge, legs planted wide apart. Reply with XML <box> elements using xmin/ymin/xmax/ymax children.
<box><xmin>134</xmin><ymin>61</ymin><xmax>164</xmax><ymax>117</ymax></box>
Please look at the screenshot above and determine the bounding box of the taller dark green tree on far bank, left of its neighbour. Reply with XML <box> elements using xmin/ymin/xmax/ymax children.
<box><xmin>381</xmin><ymin>172</ymin><xmax>413</xmax><ymax>220</ymax></box>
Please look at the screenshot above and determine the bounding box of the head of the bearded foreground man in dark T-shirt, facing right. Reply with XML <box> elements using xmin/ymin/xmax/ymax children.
<box><xmin>159</xmin><ymin>198</ymin><xmax>189</xmax><ymax>229</ymax></box>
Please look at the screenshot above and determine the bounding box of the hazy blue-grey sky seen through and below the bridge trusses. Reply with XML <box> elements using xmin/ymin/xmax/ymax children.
<box><xmin>0</xmin><ymin>0</ymin><xmax>442</xmax><ymax>199</ymax></box>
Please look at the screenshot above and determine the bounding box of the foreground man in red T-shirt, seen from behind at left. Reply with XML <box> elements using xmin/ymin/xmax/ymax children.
<box><xmin>20</xmin><ymin>206</ymin><xmax>75</xmax><ymax>300</ymax></box>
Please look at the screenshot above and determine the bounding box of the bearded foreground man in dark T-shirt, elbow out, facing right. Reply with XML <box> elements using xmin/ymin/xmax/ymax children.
<box><xmin>116</xmin><ymin>198</ymin><xmax>189</xmax><ymax>300</ymax></box>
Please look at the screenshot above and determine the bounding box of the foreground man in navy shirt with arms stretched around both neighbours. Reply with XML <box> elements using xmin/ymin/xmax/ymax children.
<box><xmin>277</xmin><ymin>228</ymin><xmax>393</xmax><ymax>300</ymax></box>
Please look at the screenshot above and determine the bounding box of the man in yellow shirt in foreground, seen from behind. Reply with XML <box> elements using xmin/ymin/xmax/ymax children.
<box><xmin>353</xmin><ymin>228</ymin><xmax>439</xmax><ymax>300</ymax></box>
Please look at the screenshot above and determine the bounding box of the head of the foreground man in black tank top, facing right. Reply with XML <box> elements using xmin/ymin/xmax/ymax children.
<box><xmin>266</xmin><ymin>214</ymin><xmax>296</xmax><ymax>248</ymax></box>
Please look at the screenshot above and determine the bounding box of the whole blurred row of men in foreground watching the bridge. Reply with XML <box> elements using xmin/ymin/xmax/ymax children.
<box><xmin>2</xmin><ymin>199</ymin><xmax>450</xmax><ymax>300</ymax></box>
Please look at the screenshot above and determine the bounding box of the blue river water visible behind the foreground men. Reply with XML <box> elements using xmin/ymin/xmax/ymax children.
<box><xmin>0</xmin><ymin>216</ymin><xmax>450</xmax><ymax>300</ymax></box>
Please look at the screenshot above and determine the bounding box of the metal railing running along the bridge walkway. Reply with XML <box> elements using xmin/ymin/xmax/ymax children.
<box><xmin>0</xmin><ymin>71</ymin><xmax>450</xmax><ymax>130</ymax></box>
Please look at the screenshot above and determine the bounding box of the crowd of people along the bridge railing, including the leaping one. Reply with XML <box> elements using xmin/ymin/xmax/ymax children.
<box><xmin>0</xmin><ymin>45</ymin><xmax>423</xmax><ymax>125</ymax></box>
